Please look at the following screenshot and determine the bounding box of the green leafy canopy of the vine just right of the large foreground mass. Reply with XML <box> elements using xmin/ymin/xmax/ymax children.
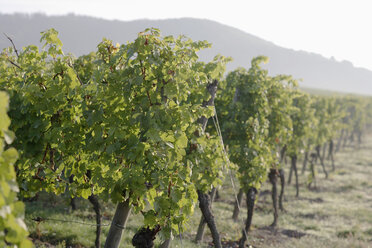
<box><xmin>217</xmin><ymin>57</ymin><xmax>289</xmax><ymax>189</ymax></box>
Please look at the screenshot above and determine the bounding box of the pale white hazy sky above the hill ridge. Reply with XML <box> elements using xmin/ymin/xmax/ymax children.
<box><xmin>0</xmin><ymin>0</ymin><xmax>372</xmax><ymax>70</ymax></box>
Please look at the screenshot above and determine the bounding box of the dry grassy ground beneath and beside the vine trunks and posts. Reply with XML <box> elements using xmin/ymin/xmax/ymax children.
<box><xmin>26</xmin><ymin>136</ymin><xmax>372</xmax><ymax>248</ymax></box>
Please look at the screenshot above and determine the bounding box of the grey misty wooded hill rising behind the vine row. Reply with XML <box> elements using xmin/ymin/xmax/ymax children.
<box><xmin>0</xmin><ymin>14</ymin><xmax>372</xmax><ymax>95</ymax></box>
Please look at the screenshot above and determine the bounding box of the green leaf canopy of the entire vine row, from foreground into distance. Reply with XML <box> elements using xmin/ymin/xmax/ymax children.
<box><xmin>0</xmin><ymin>26</ymin><xmax>372</xmax><ymax>244</ymax></box>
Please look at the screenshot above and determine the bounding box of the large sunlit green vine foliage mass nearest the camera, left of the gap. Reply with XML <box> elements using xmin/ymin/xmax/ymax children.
<box><xmin>0</xmin><ymin>29</ymin><xmax>228</xmax><ymax>237</ymax></box>
